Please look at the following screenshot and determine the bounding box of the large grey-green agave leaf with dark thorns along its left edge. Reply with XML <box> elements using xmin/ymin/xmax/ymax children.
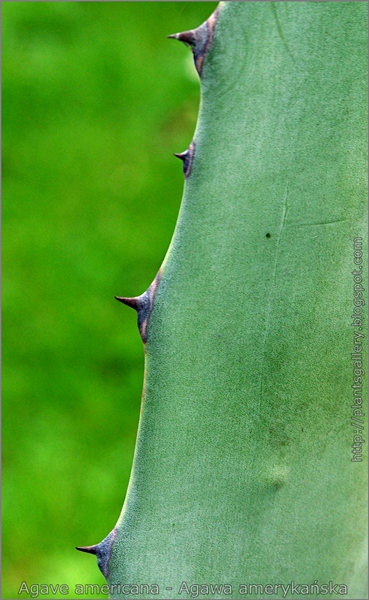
<box><xmin>82</xmin><ymin>2</ymin><xmax>367</xmax><ymax>598</ymax></box>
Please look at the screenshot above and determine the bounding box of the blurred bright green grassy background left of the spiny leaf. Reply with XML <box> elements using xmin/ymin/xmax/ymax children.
<box><xmin>2</xmin><ymin>2</ymin><xmax>216</xmax><ymax>598</ymax></box>
